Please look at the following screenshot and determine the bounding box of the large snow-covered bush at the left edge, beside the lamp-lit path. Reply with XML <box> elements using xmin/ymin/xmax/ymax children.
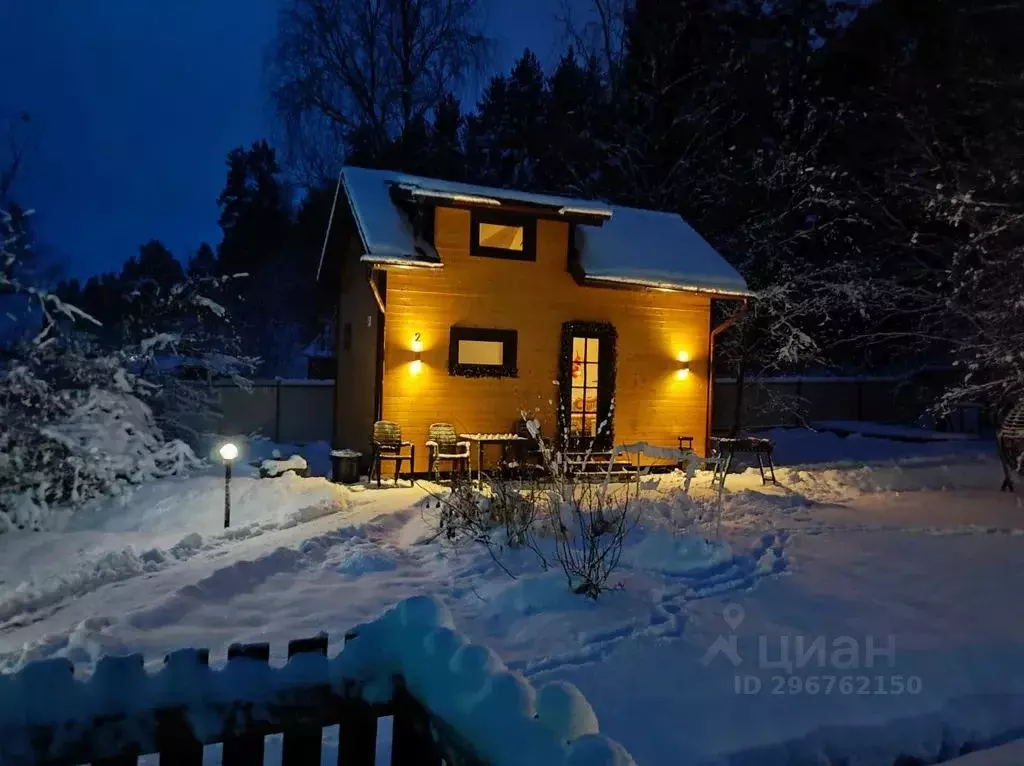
<box><xmin>0</xmin><ymin>209</ymin><xmax>199</xmax><ymax>531</ymax></box>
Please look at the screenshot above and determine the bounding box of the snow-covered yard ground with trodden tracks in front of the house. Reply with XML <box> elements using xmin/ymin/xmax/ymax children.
<box><xmin>0</xmin><ymin>431</ymin><xmax>1024</xmax><ymax>766</ymax></box>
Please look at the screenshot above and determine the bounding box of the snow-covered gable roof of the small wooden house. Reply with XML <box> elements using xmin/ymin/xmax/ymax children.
<box><xmin>341</xmin><ymin>167</ymin><xmax>750</xmax><ymax>295</ymax></box>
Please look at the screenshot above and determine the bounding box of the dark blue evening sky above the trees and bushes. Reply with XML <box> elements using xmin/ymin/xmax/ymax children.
<box><xmin>0</xmin><ymin>0</ymin><xmax>573</xmax><ymax>276</ymax></box>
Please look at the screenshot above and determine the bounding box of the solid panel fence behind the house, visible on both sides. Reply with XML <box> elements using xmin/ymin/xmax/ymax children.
<box><xmin>188</xmin><ymin>373</ymin><xmax>970</xmax><ymax>443</ymax></box>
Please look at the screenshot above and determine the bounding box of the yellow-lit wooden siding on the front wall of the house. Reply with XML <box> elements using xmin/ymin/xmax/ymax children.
<box><xmin>383</xmin><ymin>208</ymin><xmax>710</xmax><ymax>470</ymax></box>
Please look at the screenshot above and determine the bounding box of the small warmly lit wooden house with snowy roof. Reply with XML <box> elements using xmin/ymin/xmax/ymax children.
<box><xmin>334</xmin><ymin>167</ymin><xmax>749</xmax><ymax>471</ymax></box>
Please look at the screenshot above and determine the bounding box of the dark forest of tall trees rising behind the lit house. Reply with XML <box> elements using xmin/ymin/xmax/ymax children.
<box><xmin>6</xmin><ymin>0</ymin><xmax>1024</xmax><ymax>413</ymax></box>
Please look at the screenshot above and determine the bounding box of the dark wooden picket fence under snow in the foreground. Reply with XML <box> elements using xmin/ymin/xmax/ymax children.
<box><xmin>0</xmin><ymin>632</ymin><xmax>485</xmax><ymax>766</ymax></box>
